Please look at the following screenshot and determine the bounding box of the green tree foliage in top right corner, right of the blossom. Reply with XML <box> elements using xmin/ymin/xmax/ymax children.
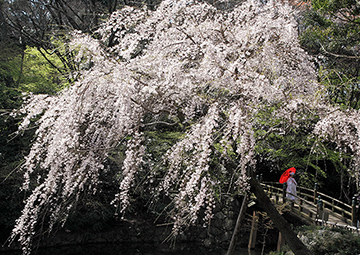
<box><xmin>300</xmin><ymin>0</ymin><xmax>360</xmax><ymax>109</ymax></box>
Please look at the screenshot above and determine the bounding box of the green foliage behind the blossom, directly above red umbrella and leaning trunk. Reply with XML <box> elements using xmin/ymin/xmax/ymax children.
<box><xmin>256</xmin><ymin>105</ymin><xmax>325</xmax><ymax>187</ymax></box>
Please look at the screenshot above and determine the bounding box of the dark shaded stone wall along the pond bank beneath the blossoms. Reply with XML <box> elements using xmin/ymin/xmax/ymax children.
<box><xmin>0</xmin><ymin>197</ymin><xmax>277</xmax><ymax>251</ymax></box>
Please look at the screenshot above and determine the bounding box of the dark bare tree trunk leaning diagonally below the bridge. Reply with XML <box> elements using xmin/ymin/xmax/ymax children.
<box><xmin>250</xmin><ymin>173</ymin><xmax>312</xmax><ymax>255</ymax></box>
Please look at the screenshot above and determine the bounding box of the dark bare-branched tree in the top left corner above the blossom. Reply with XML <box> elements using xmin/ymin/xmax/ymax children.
<box><xmin>1</xmin><ymin>0</ymin><xmax>166</xmax><ymax>81</ymax></box>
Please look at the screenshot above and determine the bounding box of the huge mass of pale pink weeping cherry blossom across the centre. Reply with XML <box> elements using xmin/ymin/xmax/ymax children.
<box><xmin>12</xmin><ymin>0</ymin><xmax>358</xmax><ymax>254</ymax></box>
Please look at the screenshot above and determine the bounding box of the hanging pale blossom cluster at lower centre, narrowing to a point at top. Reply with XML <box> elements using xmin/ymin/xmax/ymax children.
<box><xmin>159</xmin><ymin>103</ymin><xmax>219</xmax><ymax>233</ymax></box>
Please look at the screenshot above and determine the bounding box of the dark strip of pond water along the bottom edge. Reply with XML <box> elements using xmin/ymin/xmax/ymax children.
<box><xmin>4</xmin><ymin>244</ymin><xmax>269</xmax><ymax>255</ymax></box>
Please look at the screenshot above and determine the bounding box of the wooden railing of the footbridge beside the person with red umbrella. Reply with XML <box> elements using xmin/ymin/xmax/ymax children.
<box><xmin>261</xmin><ymin>182</ymin><xmax>358</xmax><ymax>226</ymax></box>
